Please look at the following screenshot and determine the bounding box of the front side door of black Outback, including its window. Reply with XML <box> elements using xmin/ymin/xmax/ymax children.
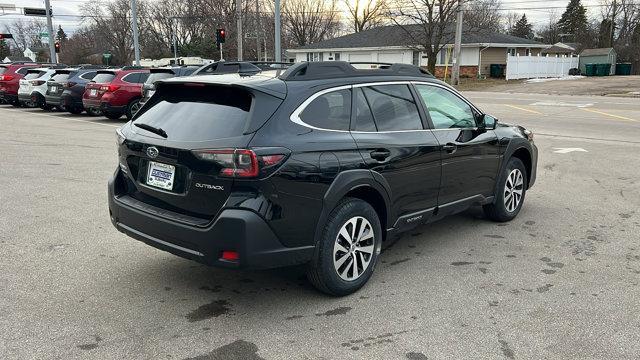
<box><xmin>414</xmin><ymin>83</ymin><xmax>499</xmax><ymax>208</ymax></box>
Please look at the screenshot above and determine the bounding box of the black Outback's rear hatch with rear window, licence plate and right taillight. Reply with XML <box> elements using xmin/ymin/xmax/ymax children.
<box><xmin>119</xmin><ymin>82</ymin><xmax>284</xmax><ymax>222</ymax></box>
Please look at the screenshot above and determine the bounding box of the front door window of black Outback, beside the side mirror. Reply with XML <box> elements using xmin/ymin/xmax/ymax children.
<box><xmin>416</xmin><ymin>85</ymin><xmax>476</xmax><ymax>129</ymax></box>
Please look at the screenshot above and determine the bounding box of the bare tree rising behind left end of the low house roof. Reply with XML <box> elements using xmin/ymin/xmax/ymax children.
<box><xmin>282</xmin><ymin>0</ymin><xmax>341</xmax><ymax>46</ymax></box>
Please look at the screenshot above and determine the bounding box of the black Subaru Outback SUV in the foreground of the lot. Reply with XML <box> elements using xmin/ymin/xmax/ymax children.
<box><xmin>108</xmin><ymin>62</ymin><xmax>537</xmax><ymax>295</ymax></box>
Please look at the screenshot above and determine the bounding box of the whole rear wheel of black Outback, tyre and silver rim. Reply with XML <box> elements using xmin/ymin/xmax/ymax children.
<box><xmin>307</xmin><ymin>198</ymin><xmax>382</xmax><ymax>296</ymax></box>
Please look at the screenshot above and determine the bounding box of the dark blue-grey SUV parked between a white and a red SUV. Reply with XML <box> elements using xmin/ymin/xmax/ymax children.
<box><xmin>45</xmin><ymin>65</ymin><xmax>104</xmax><ymax>115</ymax></box>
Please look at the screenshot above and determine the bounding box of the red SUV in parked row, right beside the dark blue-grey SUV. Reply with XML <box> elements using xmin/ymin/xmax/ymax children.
<box><xmin>82</xmin><ymin>67</ymin><xmax>149</xmax><ymax>119</ymax></box>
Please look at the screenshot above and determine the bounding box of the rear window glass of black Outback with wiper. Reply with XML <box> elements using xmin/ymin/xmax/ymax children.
<box><xmin>134</xmin><ymin>86</ymin><xmax>252</xmax><ymax>141</ymax></box>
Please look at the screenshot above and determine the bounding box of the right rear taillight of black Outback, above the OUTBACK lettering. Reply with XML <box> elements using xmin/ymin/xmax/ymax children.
<box><xmin>193</xmin><ymin>149</ymin><xmax>285</xmax><ymax>178</ymax></box>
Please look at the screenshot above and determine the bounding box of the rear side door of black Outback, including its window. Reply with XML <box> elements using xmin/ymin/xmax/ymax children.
<box><xmin>351</xmin><ymin>83</ymin><xmax>440</xmax><ymax>227</ymax></box>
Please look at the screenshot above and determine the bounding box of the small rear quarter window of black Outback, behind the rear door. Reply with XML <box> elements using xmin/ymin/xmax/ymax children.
<box><xmin>300</xmin><ymin>90</ymin><xmax>351</xmax><ymax>130</ymax></box>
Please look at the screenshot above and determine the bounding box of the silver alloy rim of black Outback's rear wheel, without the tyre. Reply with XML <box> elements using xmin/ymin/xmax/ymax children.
<box><xmin>333</xmin><ymin>216</ymin><xmax>375</xmax><ymax>281</ymax></box>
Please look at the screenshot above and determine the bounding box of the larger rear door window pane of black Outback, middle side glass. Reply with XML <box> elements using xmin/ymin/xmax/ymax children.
<box><xmin>362</xmin><ymin>85</ymin><xmax>423</xmax><ymax>131</ymax></box>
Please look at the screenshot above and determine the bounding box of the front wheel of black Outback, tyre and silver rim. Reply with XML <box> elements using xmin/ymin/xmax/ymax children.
<box><xmin>483</xmin><ymin>158</ymin><xmax>527</xmax><ymax>222</ymax></box>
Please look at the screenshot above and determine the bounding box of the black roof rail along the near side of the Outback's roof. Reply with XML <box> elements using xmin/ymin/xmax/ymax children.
<box><xmin>280</xmin><ymin>61</ymin><xmax>433</xmax><ymax>81</ymax></box>
